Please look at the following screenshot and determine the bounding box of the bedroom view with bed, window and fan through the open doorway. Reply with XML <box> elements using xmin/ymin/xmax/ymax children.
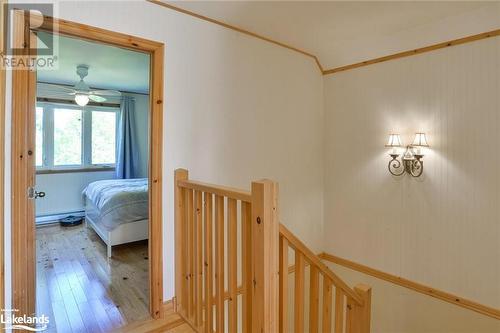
<box><xmin>34</xmin><ymin>33</ymin><xmax>150</xmax><ymax>332</ymax></box>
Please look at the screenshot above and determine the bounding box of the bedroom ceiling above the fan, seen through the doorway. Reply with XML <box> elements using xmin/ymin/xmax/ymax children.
<box><xmin>37</xmin><ymin>31</ymin><xmax>149</xmax><ymax>93</ymax></box>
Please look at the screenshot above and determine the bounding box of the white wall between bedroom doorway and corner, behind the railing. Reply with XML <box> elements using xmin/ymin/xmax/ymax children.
<box><xmin>6</xmin><ymin>1</ymin><xmax>323</xmax><ymax>299</ymax></box>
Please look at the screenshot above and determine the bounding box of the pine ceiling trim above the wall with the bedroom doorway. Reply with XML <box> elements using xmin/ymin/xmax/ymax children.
<box><xmin>146</xmin><ymin>0</ymin><xmax>323</xmax><ymax>73</ymax></box>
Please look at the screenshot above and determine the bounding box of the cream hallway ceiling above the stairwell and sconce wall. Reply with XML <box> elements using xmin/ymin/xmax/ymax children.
<box><xmin>164</xmin><ymin>1</ymin><xmax>500</xmax><ymax>69</ymax></box>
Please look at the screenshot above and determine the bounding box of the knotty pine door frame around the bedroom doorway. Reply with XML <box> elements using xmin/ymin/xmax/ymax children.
<box><xmin>11</xmin><ymin>13</ymin><xmax>164</xmax><ymax>318</ymax></box>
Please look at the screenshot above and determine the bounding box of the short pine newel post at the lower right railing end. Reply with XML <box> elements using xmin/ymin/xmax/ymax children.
<box><xmin>346</xmin><ymin>283</ymin><xmax>372</xmax><ymax>333</ymax></box>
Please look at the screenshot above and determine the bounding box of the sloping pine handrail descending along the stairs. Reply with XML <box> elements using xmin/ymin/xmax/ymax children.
<box><xmin>280</xmin><ymin>224</ymin><xmax>363</xmax><ymax>305</ymax></box>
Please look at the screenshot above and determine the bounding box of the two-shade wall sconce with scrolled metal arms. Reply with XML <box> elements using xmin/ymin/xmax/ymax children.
<box><xmin>385</xmin><ymin>133</ymin><xmax>429</xmax><ymax>177</ymax></box>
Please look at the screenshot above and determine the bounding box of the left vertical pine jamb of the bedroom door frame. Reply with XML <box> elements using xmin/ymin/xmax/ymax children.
<box><xmin>11</xmin><ymin>11</ymin><xmax>36</xmax><ymax>315</ymax></box>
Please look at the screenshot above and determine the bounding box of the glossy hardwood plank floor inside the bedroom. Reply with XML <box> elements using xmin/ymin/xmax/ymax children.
<box><xmin>36</xmin><ymin>224</ymin><xmax>149</xmax><ymax>333</ymax></box>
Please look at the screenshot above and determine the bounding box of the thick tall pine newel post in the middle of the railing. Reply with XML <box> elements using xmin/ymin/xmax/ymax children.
<box><xmin>251</xmin><ymin>180</ymin><xmax>279</xmax><ymax>333</ymax></box>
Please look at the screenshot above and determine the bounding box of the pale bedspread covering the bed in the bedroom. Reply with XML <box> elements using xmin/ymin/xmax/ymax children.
<box><xmin>82</xmin><ymin>178</ymin><xmax>149</xmax><ymax>230</ymax></box>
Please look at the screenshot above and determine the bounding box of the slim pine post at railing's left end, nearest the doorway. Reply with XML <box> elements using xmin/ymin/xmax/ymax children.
<box><xmin>174</xmin><ymin>169</ymin><xmax>188</xmax><ymax>312</ymax></box>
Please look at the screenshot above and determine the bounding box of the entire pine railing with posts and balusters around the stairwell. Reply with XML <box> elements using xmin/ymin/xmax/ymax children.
<box><xmin>175</xmin><ymin>169</ymin><xmax>371</xmax><ymax>333</ymax></box>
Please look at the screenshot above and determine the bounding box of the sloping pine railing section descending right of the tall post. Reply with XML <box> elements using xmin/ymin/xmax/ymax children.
<box><xmin>279</xmin><ymin>224</ymin><xmax>371</xmax><ymax>333</ymax></box>
